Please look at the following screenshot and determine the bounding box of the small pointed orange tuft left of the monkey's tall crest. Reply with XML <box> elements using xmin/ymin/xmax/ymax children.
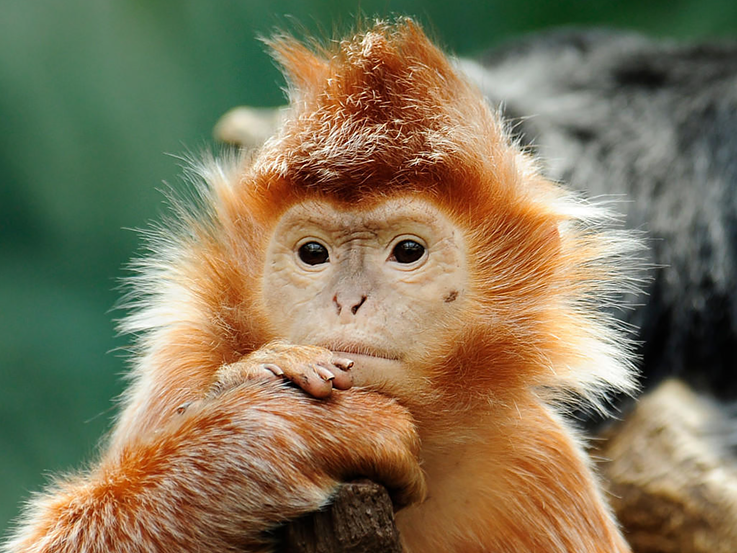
<box><xmin>264</xmin><ymin>35</ymin><xmax>330</xmax><ymax>92</ymax></box>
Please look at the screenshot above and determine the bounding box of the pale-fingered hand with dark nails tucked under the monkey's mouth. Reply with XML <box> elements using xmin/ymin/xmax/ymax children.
<box><xmin>210</xmin><ymin>342</ymin><xmax>353</xmax><ymax>398</ymax></box>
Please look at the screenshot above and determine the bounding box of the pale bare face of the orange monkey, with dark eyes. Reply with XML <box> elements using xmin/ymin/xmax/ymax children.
<box><xmin>262</xmin><ymin>197</ymin><xmax>468</xmax><ymax>388</ymax></box>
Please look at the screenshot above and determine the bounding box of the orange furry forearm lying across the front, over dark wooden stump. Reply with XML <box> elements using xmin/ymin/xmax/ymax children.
<box><xmin>6</xmin><ymin>379</ymin><xmax>424</xmax><ymax>553</ymax></box>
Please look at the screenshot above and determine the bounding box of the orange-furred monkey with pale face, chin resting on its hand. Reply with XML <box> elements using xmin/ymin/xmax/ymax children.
<box><xmin>3</xmin><ymin>18</ymin><xmax>642</xmax><ymax>553</ymax></box>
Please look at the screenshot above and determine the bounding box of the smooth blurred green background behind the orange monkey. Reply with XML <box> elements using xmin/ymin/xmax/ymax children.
<box><xmin>0</xmin><ymin>0</ymin><xmax>737</xmax><ymax>535</ymax></box>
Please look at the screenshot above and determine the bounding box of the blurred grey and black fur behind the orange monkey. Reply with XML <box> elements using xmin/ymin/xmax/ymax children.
<box><xmin>461</xmin><ymin>30</ymin><xmax>737</xmax><ymax>408</ymax></box>
